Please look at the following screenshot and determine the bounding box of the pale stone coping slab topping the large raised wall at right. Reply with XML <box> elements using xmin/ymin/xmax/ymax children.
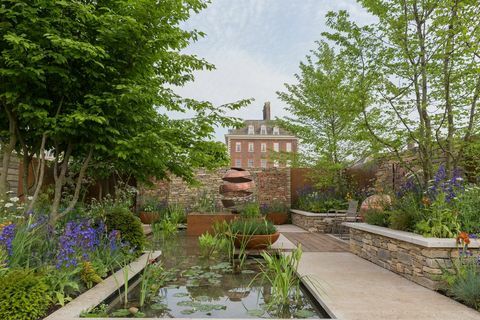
<box><xmin>342</xmin><ymin>222</ymin><xmax>480</xmax><ymax>249</ymax></box>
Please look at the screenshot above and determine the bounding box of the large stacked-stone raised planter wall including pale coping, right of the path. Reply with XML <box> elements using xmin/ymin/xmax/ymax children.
<box><xmin>343</xmin><ymin>223</ymin><xmax>480</xmax><ymax>290</ymax></box>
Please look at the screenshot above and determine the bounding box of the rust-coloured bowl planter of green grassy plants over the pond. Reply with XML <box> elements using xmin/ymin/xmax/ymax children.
<box><xmin>230</xmin><ymin>218</ymin><xmax>280</xmax><ymax>250</ymax></box>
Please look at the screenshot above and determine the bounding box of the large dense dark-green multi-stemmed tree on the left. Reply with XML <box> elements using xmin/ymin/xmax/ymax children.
<box><xmin>0</xmin><ymin>0</ymin><xmax>248</xmax><ymax>222</ymax></box>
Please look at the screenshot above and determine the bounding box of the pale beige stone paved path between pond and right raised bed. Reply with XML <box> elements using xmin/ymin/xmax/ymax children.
<box><xmin>299</xmin><ymin>252</ymin><xmax>480</xmax><ymax>320</ymax></box>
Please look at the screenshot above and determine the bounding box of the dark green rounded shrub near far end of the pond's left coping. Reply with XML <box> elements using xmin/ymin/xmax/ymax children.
<box><xmin>105</xmin><ymin>206</ymin><xmax>145</xmax><ymax>252</ymax></box>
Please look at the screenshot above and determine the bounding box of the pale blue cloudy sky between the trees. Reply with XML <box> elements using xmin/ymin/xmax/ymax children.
<box><xmin>176</xmin><ymin>0</ymin><xmax>371</xmax><ymax>141</ymax></box>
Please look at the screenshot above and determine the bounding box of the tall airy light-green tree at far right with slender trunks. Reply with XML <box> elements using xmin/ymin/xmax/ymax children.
<box><xmin>324</xmin><ymin>0</ymin><xmax>480</xmax><ymax>187</ymax></box>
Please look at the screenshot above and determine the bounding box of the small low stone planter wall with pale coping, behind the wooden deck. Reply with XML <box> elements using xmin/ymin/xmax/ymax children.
<box><xmin>290</xmin><ymin>209</ymin><xmax>345</xmax><ymax>233</ymax></box>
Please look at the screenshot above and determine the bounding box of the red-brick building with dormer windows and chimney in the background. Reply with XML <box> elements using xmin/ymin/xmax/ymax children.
<box><xmin>225</xmin><ymin>102</ymin><xmax>298</xmax><ymax>168</ymax></box>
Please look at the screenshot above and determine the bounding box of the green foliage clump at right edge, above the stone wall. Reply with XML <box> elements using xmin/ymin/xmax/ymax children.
<box><xmin>453</xmin><ymin>185</ymin><xmax>480</xmax><ymax>233</ymax></box>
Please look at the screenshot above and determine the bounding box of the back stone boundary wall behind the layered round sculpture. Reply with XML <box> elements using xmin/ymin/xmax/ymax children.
<box><xmin>139</xmin><ymin>168</ymin><xmax>291</xmax><ymax>210</ymax></box>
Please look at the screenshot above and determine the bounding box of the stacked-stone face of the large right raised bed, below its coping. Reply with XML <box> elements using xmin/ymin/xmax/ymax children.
<box><xmin>350</xmin><ymin>228</ymin><xmax>478</xmax><ymax>290</ymax></box>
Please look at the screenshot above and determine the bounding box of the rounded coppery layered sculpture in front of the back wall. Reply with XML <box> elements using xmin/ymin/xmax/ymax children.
<box><xmin>220</xmin><ymin>168</ymin><xmax>255</xmax><ymax>213</ymax></box>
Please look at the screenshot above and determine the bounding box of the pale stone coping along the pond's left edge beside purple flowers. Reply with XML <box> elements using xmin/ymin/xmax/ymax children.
<box><xmin>44</xmin><ymin>251</ymin><xmax>161</xmax><ymax>320</ymax></box>
